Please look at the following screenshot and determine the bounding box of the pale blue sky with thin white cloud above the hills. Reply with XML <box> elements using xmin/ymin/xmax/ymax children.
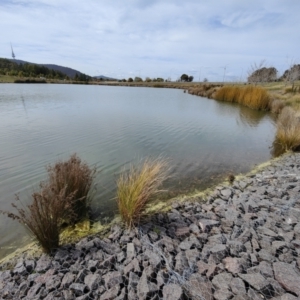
<box><xmin>0</xmin><ymin>0</ymin><xmax>300</xmax><ymax>81</ymax></box>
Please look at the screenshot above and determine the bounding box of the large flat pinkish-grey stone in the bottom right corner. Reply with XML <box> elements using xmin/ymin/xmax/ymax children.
<box><xmin>273</xmin><ymin>262</ymin><xmax>300</xmax><ymax>297</ymax></box>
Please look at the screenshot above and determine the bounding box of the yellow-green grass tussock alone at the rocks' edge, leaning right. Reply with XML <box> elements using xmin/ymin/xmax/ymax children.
<box><xmin>117</xmin><ymin>159</ymin><xmax>169</xmax><ymax>228</ymax></box>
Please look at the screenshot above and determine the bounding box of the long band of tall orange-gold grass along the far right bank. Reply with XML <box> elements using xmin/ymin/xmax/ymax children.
<box><xmin>214</xmin><ymin>85</ymin><xmax>271</xmax><ymax>110</ymax></box>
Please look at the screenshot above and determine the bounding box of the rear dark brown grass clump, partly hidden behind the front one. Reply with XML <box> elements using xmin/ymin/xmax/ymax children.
<box><xmin>47</xmin><ymin>154</ymin><xmax>96</xmax><ymax>224</ymax></box>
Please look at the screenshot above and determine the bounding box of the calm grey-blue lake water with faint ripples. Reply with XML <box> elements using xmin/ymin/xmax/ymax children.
<box><xmin>0</xmin><ymin>84</ymin><xmax>275</xmax><ymax>257</ymax></box>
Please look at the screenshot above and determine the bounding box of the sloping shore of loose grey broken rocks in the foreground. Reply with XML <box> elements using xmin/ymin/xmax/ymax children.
<box><xmin>0</xmin><ymin>154</ymin><xmax>300</xmax><ymax>300</ymax></box>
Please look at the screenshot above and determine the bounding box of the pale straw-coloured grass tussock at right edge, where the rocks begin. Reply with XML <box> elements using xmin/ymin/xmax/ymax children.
<box><xmin>276</xmin><ymin>107</ymin><xmax>300</xmax><ymax>150</ymax></box>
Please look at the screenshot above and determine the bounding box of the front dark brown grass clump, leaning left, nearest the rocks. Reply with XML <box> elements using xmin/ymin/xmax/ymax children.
<box><xmin>0</xmin><ymin>183</ymin><xmax>74</xmax><ymax>253</ymax></box>
